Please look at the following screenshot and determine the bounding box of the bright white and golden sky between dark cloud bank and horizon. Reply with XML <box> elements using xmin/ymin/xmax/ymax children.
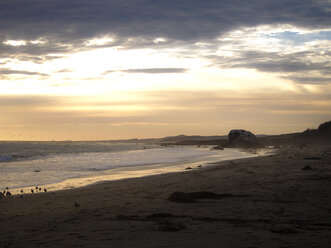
<box><xmin>0</xmin><ymin>21</ymin><xmax>331</xmax><ymax>139</ymax></box>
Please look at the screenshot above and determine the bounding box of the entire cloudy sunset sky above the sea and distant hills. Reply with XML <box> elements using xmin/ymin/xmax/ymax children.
<box><xmin>0</xmin><ymin>0</ymin><xmax>331</xmax><ymax>140</ymax></box>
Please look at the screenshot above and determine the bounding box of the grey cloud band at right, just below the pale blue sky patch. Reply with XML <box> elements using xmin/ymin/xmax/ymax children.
<box><xmin>207</xmin><ymin>50</ymin><xmax>331</xmax><ymax>84</ymax></box>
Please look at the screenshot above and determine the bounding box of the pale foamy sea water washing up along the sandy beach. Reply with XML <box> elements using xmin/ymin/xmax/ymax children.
<box><xmin>0</xmin><ymin>142</ymin><xmax>264</xmax><ymax>194</ymax></box>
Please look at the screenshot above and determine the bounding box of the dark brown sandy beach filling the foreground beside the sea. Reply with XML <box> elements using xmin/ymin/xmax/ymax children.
<box><xmin>0</xmin><ymin>147</ymin><xmax>331</xmax><ymax>248</ymax></box>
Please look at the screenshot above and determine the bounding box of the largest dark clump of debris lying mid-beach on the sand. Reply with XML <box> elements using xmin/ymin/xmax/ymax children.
<box><xmin>168</xmin><ymin>191</ymin><xmax>236</xmax><ymax>203</ymax></box>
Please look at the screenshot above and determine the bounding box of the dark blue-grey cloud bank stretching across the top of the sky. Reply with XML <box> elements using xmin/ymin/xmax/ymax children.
<box><xmin>0</xmin><ymin>0</ymin><xmax>330</xmax><ymax>55</ymax></box>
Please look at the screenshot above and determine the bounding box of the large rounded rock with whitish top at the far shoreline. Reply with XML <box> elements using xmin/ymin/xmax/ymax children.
<box><xmin>226</xmin><ymin>129</ymin><xmax>258</xmax><ymax>147</ymax></box>
